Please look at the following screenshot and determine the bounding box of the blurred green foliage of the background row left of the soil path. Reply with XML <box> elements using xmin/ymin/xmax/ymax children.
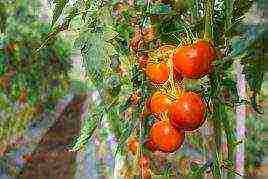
<box><xmin>0</xmin><ymin>0</ymin><xmax>72</xmax><ymax>141</ymax></box>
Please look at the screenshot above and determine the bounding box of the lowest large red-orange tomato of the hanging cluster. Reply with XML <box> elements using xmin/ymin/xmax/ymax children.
<box><xmin>150</xmin><ymin>121</ymin><xmax>185</xmax><ymax>153</ymax></box>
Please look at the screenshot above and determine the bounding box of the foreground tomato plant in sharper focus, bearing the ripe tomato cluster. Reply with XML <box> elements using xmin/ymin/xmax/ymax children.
<box><xmin>30</xmin><ymin>0</ymin><xmax>264</xmax><ymax>178</ymax></box>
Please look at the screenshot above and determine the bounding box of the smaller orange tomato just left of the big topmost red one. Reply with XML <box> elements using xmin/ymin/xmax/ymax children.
<box><xmin>146</xmin><ymin>61</ymin><xmax>169</xmax><ymax>84</ymax></box>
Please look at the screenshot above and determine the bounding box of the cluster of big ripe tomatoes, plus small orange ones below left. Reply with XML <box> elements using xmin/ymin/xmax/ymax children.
<box><xmin>129</xmin><ymin>40</ymin><xmax>215</xmax><ymax>178</ymax></box>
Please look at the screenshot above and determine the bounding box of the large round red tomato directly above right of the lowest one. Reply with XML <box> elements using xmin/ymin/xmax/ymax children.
<box><xmin>170</xmin><ymin>92</ymin><xmax>205</xmax><ymax>131</ymax></box>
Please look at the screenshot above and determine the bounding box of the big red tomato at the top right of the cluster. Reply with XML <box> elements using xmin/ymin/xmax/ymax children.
<box><xmin>173</xmin><ymin>40</ymin><xmax>215</xmax><ymax>78</ymax></box>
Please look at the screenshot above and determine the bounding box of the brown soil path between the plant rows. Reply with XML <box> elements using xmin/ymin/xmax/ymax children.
<box><xmin>20</xmin><ymin>96</ymin><xmax>86</xmax><ymax>179</ymax></box>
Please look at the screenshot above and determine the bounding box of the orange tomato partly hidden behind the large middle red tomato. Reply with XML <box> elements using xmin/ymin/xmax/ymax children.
<box><xmin>149</xmin><ymin>91</ymin><xmax>172</xmax><ymax>115</ymax></box>
